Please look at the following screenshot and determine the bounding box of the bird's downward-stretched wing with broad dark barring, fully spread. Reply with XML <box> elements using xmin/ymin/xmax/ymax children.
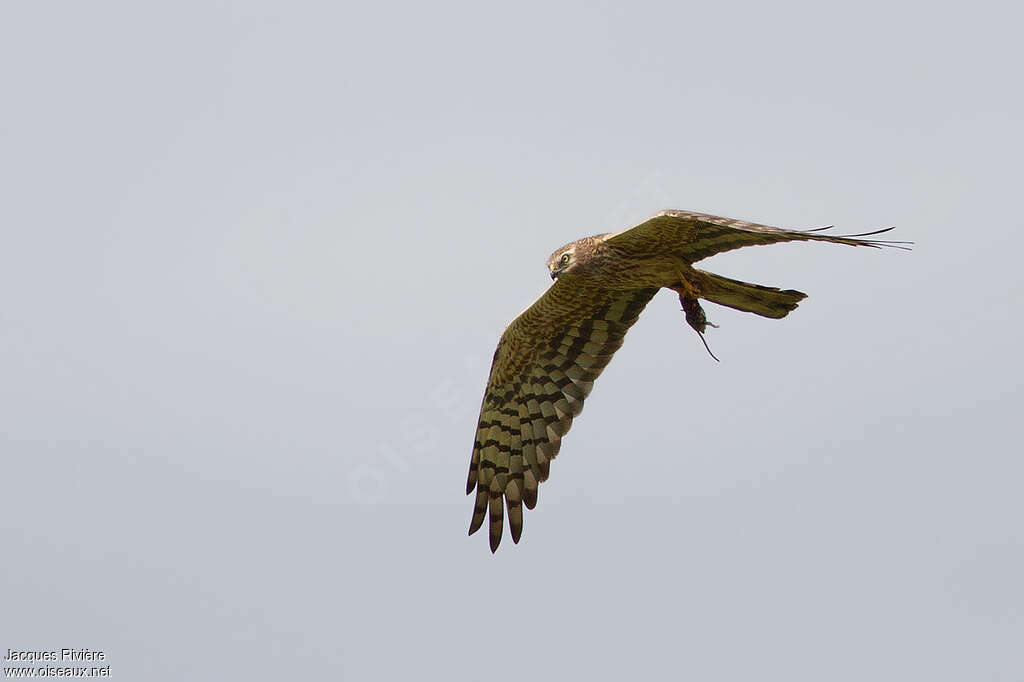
<box><xmin>466</xmin><ymin>278</ymin><xmax>657</xmax><ymax>552</ymax></box>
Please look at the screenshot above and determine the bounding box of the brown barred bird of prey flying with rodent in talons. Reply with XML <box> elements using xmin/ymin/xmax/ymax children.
<box><xmin>466</xmin><ymin>211</ymin><xmax>907</xmax><ymax>552</ymax></box>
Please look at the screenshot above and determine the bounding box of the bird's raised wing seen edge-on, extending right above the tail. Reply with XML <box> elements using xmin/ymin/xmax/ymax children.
<box><xmin>605</xmin><ymin>206</ymin><xmax>907</xmax><ymax>263</ymax></box>
